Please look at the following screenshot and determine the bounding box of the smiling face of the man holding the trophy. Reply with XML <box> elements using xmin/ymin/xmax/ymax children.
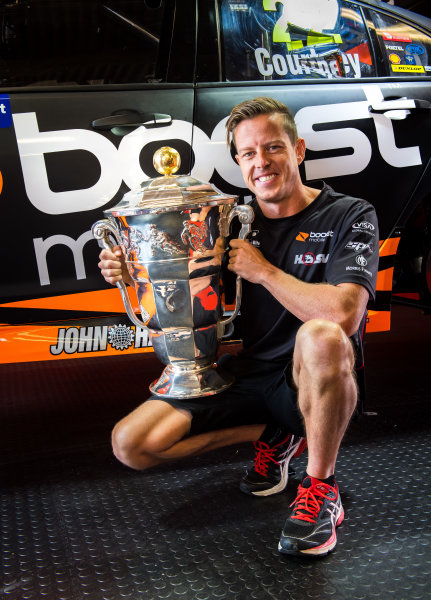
<box><xmin>235</xmin><ymin>113</ymin><xmax>305</xmax><ymax>204</ymax></box>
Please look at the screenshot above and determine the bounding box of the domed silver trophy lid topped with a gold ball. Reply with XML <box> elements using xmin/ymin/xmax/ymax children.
<box><xmin>103</xmin><ymin>146</ymin><xmax>237</xmax><ymax>217</ymax></box>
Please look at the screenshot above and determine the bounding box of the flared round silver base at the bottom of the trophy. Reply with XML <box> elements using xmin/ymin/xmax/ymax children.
<box><xmin>150</xmin><ymin>364</ymin><xmax>234</xmax><ymax>398</ymax></box>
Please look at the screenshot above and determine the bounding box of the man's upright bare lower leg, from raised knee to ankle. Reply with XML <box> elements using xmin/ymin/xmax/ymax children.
<box><xmin>293</xmin><ymin>319</ymin><xmax>357</xmax><ymax>479</ymax></box>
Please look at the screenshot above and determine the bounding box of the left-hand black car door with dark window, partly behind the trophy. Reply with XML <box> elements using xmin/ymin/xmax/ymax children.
<box><xmin>0</xmin><ymin>0</ymin><xmax>195</xmax><ymax>360</ymax></box>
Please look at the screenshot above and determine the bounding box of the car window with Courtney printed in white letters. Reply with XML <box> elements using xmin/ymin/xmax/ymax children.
<box><xmin>219</xmin><ymin>0</ymin><xmax>375</xmax><ymax>81</ymax></box>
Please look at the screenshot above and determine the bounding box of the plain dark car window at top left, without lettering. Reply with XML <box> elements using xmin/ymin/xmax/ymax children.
<box><xmin>0</xmin><ymin>0</ymin><xmax>167</xmax><ymax>88</ymax></box>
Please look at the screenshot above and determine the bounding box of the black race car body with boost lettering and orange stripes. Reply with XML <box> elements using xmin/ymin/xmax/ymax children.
<box><xmin>0</xmin><ymin>0</ymin><xmax>431</xmax><ymax>363</ymax></box>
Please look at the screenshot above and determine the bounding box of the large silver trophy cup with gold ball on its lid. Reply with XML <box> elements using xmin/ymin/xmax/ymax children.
<box><xmin>93</xmin><ymin>147</ymin><xmax>254</xmax><ymax>398</ymax></box>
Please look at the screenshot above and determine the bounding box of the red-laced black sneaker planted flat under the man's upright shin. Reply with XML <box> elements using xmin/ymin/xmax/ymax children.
<box><xmin>278</xmin><ymin>476</ymin><xmax>344</xmax><ymax>556</ymax></box>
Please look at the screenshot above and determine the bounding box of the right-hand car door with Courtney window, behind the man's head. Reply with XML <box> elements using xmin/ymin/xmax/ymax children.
<box><xmin>196</xmin><ymin>0</ymin><xmax>431</xmax><ymax>330</ymax></box>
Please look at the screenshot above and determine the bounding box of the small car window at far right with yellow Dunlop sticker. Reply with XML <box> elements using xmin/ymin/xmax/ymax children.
<box><xmin>366</xmin><ymin>10</ymin><xmax>431</xmax><ymax>77</ymax></box>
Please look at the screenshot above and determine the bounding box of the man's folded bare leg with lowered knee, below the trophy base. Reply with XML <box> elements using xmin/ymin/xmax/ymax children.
<box><xmin>112</xmin><ymin>399</ymin><xmax>265</xmax><ymax>469</ymax></box>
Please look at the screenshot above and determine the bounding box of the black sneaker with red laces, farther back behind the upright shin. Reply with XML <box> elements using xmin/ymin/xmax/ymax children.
<box><xmin>240</xmin><ymin>433</ymin><xmax>307</xmax><ymax>496</ymax></box>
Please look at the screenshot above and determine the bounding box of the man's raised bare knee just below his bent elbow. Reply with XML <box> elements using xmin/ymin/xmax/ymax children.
<box><xmin>294</xmin><ymin>319</ymin><xmax>354</xmax><ymax>377</ymax></box>
